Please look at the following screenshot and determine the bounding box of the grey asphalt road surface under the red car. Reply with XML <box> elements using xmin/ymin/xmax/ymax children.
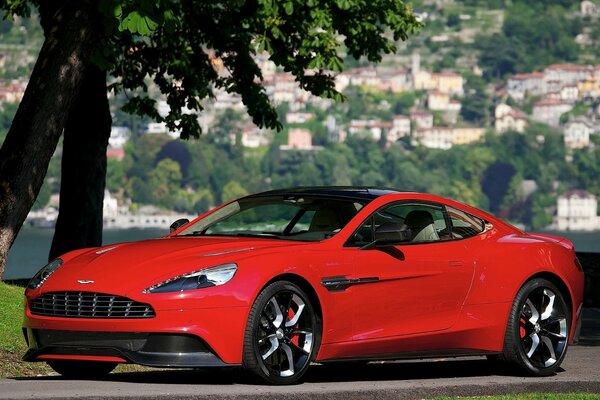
<box><xmin>0</xmin><ymin>309</ymin><xmax>600</xmax><ymax>400</ymax></box>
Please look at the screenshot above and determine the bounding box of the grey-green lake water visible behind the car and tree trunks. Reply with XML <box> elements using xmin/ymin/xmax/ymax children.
<box><xmin>4</xmin><ymin>227</ymin><xmax>600</xmax><ymax>279</ymax></box>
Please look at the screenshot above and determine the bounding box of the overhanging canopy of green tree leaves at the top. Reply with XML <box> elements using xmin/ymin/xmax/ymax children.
<box><xmin>96</xmin><ymin>0</ymin><xmax>421</xmax><ymax>138</ymax></box>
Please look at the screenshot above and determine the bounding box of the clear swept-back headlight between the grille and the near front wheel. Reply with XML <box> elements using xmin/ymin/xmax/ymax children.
<box><xmin>144</xmin><ymin>263</ymin><xmax>237</xmax><ymax>293</ymax></box>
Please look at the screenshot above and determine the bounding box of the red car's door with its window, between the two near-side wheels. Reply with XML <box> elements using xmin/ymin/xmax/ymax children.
<box><xmin>346</xmin><ymin>202</ymin><xmax>474</xmax><ymax>341</ymax></box>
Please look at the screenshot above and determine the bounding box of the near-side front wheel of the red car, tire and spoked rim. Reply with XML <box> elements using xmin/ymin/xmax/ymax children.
<box><xmin>242</xmin><ymin>281</ymin><xmax>321</xmax><ymax>385</ymax></box>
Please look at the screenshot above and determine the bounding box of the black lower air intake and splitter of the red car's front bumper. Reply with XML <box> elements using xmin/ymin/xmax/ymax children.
<box><xmin>23</xmin><ymin>328</ymin><xmax>235</xmax><ymax>367</ymax></box>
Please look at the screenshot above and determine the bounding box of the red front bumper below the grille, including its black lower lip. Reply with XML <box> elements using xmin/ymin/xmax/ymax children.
<box><xmin>23</xmin><ymin>307</ymin><xmax>249</xmax><ymax>367</ymax></box>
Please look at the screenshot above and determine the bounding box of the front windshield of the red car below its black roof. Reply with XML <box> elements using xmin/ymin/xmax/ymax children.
<box><xmin>178</xmin><ymin>196</ymin><xmax>365</xmax><ymax>241</ymax></box>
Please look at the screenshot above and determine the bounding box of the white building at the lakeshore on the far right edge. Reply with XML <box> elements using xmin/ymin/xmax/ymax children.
<box><xmin>555</xmin><ymin>190</ymin><xmax>600</xmax><ymax>231</ymax></box>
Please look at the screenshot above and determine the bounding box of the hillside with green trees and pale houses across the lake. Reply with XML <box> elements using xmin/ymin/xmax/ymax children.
<box><xmin>0</xmin><ymin>0</ymin><xmax>600</xmax><ymax>229</ymax></box>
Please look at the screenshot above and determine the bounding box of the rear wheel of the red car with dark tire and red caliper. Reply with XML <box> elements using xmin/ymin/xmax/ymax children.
<box><xmin>499</xmin><ymin>278</ymin><xmax>571</xmax><ymax>376</ymax></box>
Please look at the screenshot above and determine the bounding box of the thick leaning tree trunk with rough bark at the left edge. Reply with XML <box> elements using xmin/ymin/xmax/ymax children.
<box><xmin>0</xmin><ymin>0</ymin><xmax>99</xmax><ymax>276</ymax></box>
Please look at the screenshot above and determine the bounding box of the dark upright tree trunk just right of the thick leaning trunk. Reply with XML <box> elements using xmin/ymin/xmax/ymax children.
<box><xmin>48</xmin><ymin>66</ymin><xmax>111</xmax><ymax>261</ymax></box>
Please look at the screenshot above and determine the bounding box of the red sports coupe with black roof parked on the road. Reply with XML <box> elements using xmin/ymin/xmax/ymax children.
<box><xmin>23</xmin><ymin>187</ymin><xmax>584</xmax><ymax>384</ymax></box>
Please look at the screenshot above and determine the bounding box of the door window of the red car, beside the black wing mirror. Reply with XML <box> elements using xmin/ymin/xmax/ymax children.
<box><xmin>348</xmin><ymin>202</ymin><xmax>452</xmax><ymax>245</ymax></box>
